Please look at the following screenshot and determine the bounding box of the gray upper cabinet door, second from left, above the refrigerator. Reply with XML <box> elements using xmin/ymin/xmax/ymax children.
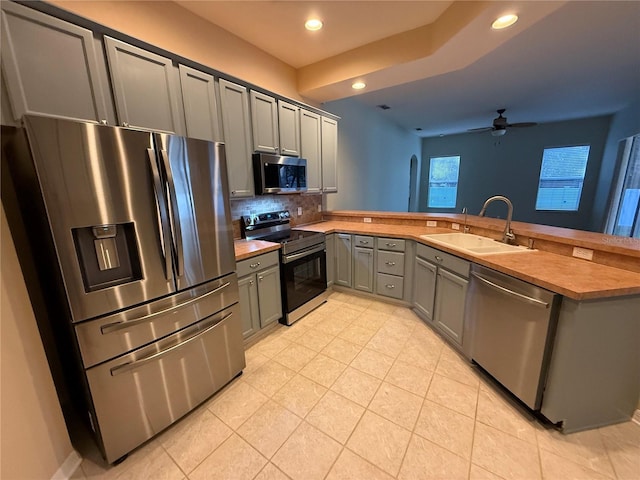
<box><xmin>104</xmin><ymin>37</ymin><xmax>184</xmax><ymax>134</ymax></box>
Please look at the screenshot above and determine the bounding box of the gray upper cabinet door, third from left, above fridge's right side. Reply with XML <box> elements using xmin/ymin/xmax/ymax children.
<box><xmin>178</xmin><ymin>65</ymin><xmax>222</xmax><ymax>142</ymax></box>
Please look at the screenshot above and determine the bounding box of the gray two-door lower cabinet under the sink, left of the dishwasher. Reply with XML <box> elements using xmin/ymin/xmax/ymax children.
<box><xmin>413</xmin><ymin>244</ymin><xmax>471</xmax><ymax>350</ymax></box>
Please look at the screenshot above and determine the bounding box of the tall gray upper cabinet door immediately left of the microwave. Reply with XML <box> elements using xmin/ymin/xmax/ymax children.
<box><xmin>220</xmin><ymin>79</ymin><xmax>253</xmax><ymax>198</ymax></box>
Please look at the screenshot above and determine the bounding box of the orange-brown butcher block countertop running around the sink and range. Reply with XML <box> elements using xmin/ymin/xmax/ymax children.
<box><xmin>235</xmin><ymin>220</ymin><xmax>640</xmax><ymax>300</ymax></box>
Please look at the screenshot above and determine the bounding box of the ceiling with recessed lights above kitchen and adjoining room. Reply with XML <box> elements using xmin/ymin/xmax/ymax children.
<box><xmin>177</xmin><ymin>0</ymin><xmax>640</xmax><ymax>136</ymax></box>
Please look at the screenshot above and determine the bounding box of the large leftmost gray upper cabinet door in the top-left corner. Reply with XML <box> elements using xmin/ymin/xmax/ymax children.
<box><xmin>1</xmin><ymin>2</ymin><xmax>108</xmax><ymax>122</ymax></box>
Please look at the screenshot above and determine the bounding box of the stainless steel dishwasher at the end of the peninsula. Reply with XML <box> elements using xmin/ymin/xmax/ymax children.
<box><xmin>466</xmin><ymin>264</ymin><xmax>561</xmax><ymax>410</ymax></box>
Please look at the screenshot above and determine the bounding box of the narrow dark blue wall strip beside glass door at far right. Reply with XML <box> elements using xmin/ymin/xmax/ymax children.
<box><xmin>590</xmin><ymin>100</ymin><xmax>640</xmax><ymax>232</ymax></box>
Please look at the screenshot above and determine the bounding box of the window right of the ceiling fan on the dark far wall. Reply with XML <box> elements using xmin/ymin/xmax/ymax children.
<box><xmin>536</xmin><ymin>145</ymin><xmax>589</xmax><ymax>212</ymax></box>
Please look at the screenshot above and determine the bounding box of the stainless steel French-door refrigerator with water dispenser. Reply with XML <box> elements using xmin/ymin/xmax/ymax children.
<box><xmin>5</xmin><ymin>116</ymin><xmax>245</xmax><ymax>463</ymax></box>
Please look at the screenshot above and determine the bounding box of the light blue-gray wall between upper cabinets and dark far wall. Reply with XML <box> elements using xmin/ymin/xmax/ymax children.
<box><xmin>322</xmin><ymin>99</ymin><xmax>420</xmax><ymax>212</ymax></box>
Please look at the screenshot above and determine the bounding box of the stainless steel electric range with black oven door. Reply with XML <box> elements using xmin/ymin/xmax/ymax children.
<box><xmin>240</xmin><ymin>210</ymin><xmax>328</xmax><ymax>325</ymax></box>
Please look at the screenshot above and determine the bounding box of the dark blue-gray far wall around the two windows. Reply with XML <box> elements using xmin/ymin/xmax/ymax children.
<box><xmin>419</xmin><ymin>116</ymin><xmax>611</xmax><ymax>230</ymax></box>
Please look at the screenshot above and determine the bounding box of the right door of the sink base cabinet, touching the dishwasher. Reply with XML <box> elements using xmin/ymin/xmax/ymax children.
<box><xmin>435</xmin><ymin>268</ymin><xmax>469</xmax><ymax>346</ymax></box>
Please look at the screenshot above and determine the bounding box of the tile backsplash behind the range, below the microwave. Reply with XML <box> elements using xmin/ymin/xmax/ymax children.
<box><xmin>230</xmin><ymin>194</ymin><xmax>322</xmax><ymax>238</ymax></box>
